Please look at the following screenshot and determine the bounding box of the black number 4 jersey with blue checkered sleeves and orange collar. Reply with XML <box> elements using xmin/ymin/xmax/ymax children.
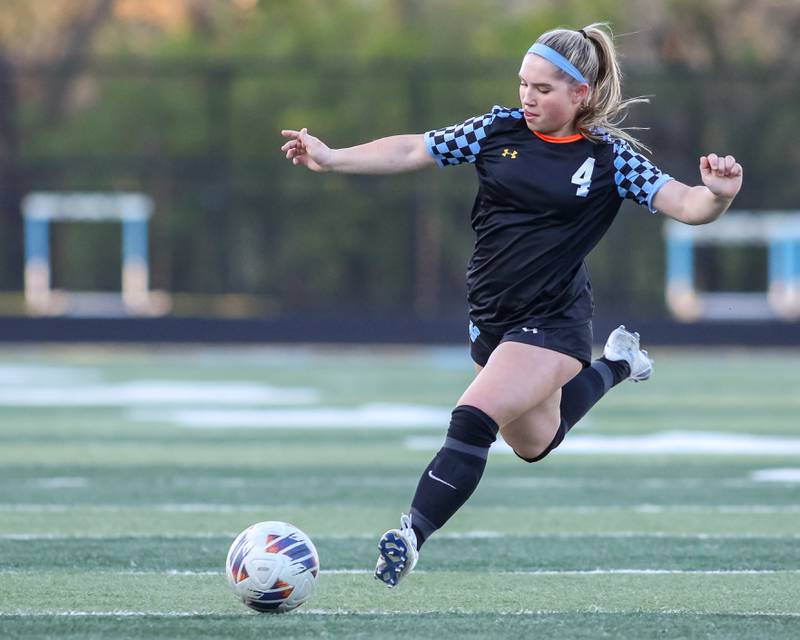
<box><xmin>425</xmin><ymin>106</ymin><xmax>671</xmax><ymax>335</ymax></box>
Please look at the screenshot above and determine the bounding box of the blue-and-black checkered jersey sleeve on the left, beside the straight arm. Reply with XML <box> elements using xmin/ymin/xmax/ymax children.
<box><xmin>425</xmin><ymin>106</ymin><xmax>522</xmax><ymax>167</ymax></box>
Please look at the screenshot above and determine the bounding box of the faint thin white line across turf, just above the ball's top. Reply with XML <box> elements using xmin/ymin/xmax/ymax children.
<box><xmin>0</xmin><ymin>502</ymin><xmax>800</xmax><ymax>514</ymax></box>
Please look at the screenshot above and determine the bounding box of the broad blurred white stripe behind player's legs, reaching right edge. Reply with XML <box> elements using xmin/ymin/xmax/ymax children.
<box><xmin>405</xmin><ymin>431</ymin><xmax>800</xmax><ymax>456</ymax></box>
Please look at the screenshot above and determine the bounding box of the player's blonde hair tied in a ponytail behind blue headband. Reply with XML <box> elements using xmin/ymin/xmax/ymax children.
<box><xmin>537</xmin><ymin>22</ymin><xmax>649</xmax><ymax>151</ymax></box>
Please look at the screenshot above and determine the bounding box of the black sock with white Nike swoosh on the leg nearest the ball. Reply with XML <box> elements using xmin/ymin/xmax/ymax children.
<box><xmin>411</xmin><ymin>406</ymin><xmax>497</xmax><ymax>548</ymax></box>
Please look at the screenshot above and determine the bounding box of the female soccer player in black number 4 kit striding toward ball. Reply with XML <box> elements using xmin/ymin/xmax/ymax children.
<box><xmin>282</xmin><ymin>23</ymin><xmax>742</xmax><ymax>586</ymax></box>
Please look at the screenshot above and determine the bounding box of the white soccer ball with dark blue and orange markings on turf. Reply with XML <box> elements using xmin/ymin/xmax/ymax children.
<box><xmin>225</xmin><ymin>522</ymin><xmax>319</xmax><ymax>613</ymax></box>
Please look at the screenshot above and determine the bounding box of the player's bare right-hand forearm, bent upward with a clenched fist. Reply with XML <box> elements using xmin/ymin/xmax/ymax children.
<box><xmin>653</xmin><ymin>153</ymin><xmax>743</xmax><ymax>224</ymax></box>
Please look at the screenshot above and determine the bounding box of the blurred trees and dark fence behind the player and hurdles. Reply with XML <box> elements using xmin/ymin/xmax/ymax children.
<box><xmin>0</xmin><ymin>0</ymin><xmax>800</xmax><ymax>316</ymax></box>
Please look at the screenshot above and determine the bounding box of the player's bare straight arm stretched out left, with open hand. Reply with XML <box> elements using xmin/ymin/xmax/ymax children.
<box><xmin>281</xmin><ymin>129</ymin><xmax>436</xmax><ymax>174</ymax></box>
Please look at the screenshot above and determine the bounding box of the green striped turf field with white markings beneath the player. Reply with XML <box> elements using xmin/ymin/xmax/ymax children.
<box><xmin>0</xmin><ymin>347</ymin><xmax>800</xmax><ymax>640</ymax></box>
